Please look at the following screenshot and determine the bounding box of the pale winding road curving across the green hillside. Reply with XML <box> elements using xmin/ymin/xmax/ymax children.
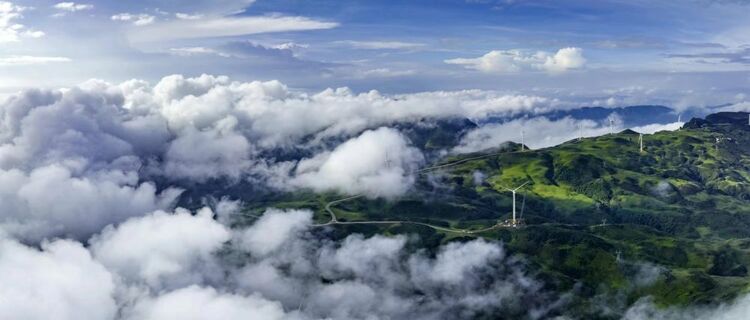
<box><xmin>313</xmin><ymin>151</ymin><xmax>523</xmax><ymax>234</ymax></box>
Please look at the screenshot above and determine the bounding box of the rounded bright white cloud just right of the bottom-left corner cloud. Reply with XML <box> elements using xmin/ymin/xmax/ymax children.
<box><xmin>90</xmin><ymin>208</ymin><xmax>230</xmax><ymax>290</ymax></box>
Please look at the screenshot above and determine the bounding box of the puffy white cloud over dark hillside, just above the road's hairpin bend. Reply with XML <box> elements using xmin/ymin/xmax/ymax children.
<box><xmin>290</xmin><ymin>128</ymin><xmax>423</xmax><ymax>197</ymax></box>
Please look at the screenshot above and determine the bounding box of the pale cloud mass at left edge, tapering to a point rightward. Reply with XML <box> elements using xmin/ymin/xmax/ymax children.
<box><xmin>0</xmin><ymin>165</ymin><xmax>180</xmax><ymax>241</ymax></box>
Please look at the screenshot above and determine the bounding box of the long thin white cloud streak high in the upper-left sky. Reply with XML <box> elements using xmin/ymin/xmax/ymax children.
<box><xmin>129</xmin><ymin>16</ymin><xmax>338</xmax><ymax>42</ymax></box>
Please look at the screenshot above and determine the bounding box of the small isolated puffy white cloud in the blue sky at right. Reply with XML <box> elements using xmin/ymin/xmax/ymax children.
<box><xmin>445</xmin><ymin>47</ymin><xmax>586</xmax><ymax>73</ymax></box>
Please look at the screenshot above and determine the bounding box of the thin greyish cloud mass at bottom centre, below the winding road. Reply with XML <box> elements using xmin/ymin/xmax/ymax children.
<box><xmin>234</xmin><ymin>212</ymin><xmax>552</xmax><ymax>319</ymax></box>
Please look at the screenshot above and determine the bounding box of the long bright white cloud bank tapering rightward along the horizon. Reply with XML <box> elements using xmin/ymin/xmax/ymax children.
<box><xmin>135</xmin><ymin>75</ymin><xmax>559</xmax><ymax>148</ymax></box>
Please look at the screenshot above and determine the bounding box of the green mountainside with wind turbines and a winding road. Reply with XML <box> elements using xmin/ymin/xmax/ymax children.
<box><xmin>246</xmin><ymin>113</ymin><xmax>750</xmax><ymax>319</ymax></box>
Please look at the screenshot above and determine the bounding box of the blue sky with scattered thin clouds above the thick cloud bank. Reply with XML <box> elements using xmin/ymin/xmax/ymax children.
<box><xmin>0</xmin><ymin>0</ymin><xmax>750</xmax><ymax>105</ymax></box>
